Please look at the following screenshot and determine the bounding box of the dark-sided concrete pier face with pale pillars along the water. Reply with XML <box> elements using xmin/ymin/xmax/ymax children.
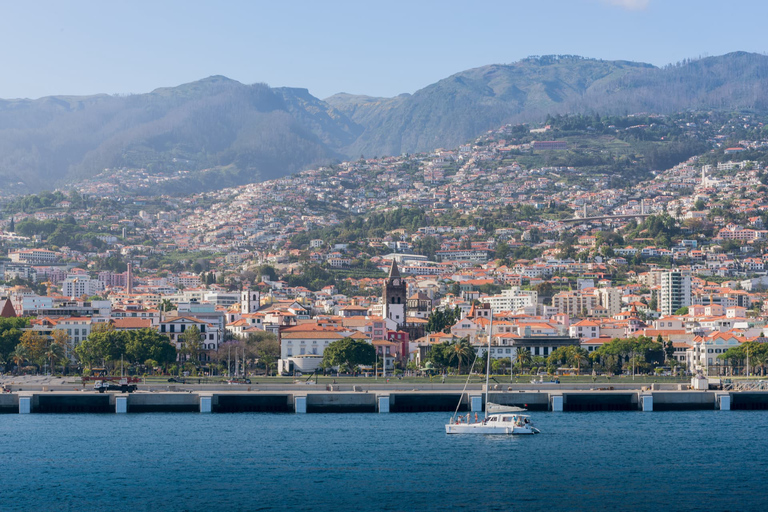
<box><xmin>0</xmin><ymin>387</ymin><xmax>768</xmax><ymax>414</ymax></box>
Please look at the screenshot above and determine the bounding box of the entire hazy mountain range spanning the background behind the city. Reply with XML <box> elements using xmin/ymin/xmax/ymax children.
<box><xmin>0</xmin><ymin>52</ymin><xmax>768</xmax><ymax>192</ymax></box>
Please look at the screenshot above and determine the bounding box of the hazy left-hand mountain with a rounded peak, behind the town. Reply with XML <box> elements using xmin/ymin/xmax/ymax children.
<box><xmin>0</xmin><ymin>76</ymin><xmax>362</xmax><ymax>194</ymax></box>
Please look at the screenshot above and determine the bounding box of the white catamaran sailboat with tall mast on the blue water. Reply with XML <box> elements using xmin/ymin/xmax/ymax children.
<box><xmin>445</xmin><ymin>311</ymin><xmax>540</xmax><ymax>435</ymax></box>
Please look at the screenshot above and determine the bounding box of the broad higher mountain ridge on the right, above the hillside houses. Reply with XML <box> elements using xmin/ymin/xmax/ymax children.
<box><xmin>325</xmin><ymin>52</ymin><xmax>768</xmax><ymax>156</ymax></box>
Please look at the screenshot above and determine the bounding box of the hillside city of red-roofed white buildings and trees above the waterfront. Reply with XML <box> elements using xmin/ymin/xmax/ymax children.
<box><xmin>0</xmin><ymin>113</ymin><xmax>768</xmax><ymax>384</ymax></box>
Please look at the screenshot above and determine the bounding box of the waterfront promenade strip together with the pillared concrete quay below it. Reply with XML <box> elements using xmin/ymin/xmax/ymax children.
<box><xmin>0</xmin><ymin>378</ymin><xmax>768</xmax><ymax>413</ymax></box>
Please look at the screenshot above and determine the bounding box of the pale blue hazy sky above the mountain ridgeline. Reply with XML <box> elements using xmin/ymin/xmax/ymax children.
<box><xmin>0</xmin><ymin>0</ymin><xmax>768</xmax><ymax>98</ymax></box>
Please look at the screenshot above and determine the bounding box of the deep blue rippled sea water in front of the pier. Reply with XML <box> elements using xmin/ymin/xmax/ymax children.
<box><xmin>0</xmin><ymin>411</ymin><xmax>768</xmax><ymax>512</ymax></box>
